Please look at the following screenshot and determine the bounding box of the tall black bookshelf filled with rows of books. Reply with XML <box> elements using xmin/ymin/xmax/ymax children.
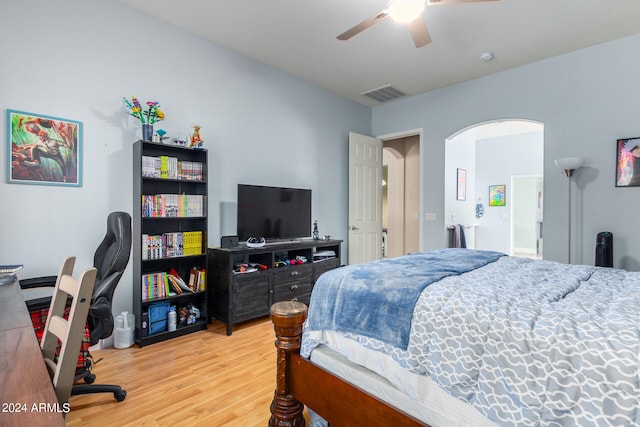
<box><xmin>132</xmin><ymin>141</ymin><xmax>208</xmax><ymax>347</ymax></box>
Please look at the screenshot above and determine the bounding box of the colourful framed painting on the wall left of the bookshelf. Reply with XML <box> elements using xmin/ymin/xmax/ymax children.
<box><xmin>7</xmin><ymin>110</ymin><xmax>82</xmax><ymax>187</ymax></box>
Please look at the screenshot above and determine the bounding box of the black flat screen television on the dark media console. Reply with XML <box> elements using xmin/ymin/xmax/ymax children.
<box><xmin>238</xmin><ymin>184</ymin><xmax>311</xmax><ymax>242</ymax></box>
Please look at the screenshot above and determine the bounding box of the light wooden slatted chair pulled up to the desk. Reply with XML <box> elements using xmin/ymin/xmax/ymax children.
<box><xmin>40</xmin><ymin>257</ymin><xmax>97</xmax><ymax>405</ymax></box>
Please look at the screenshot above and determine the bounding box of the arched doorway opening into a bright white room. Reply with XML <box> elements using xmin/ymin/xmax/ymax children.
<box><xmin>444</xmin><ymin>119</ymin><xmax>544</xmax><ymax>258</ymax></box>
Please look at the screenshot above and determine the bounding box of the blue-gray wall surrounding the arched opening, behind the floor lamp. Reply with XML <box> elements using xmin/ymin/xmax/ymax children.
<box><xmin>372</xmin><ymin>35</ymin><xmax>640</xmax><ymax>270</ymax></box>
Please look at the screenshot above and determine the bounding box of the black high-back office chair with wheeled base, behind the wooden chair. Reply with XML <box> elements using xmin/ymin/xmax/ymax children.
<box><xmin>20</xmin><ymin>212</ymin><xmax>131</xmax><ymax>402</ymax></box>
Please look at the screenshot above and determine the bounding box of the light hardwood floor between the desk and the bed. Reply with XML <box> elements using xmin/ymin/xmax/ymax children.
<box><xmin>66</xmin><ymin>317</ymin><xmax>284</xmax><ymax>426</ymax></box>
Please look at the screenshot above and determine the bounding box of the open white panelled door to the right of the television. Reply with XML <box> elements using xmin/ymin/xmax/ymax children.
<box><xmin>349</xmin><ymin>132</ymin><xmax>382</xmax><ymax>264</ymax></box>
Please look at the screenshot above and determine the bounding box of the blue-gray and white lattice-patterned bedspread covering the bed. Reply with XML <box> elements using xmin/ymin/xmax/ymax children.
<box><xmin>301</xmin><ymin>257</ymin><xmax>640</xmax><ymax>426</ymax></box>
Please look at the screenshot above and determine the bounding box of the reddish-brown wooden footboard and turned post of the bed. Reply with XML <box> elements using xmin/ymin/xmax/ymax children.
<box><xmin>269</xmin><ymin>301</ymin><xmax>426</xmax><ymax>427</ymax></box>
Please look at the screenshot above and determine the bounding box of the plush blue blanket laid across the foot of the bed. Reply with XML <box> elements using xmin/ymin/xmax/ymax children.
<box><xmin>307</xmin><ymin>249</ymin><xmax>504</xmax><ymax>348</ymax></box>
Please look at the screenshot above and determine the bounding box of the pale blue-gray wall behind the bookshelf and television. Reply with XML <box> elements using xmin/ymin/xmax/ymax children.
<box><xmin>0</xmin><ymin>0</ymin><xmax>371</xmax><ymax>313</ymax></box>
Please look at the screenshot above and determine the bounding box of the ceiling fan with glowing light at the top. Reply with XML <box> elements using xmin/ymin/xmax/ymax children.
<box><xmin>337</xmin><ymin>0</ymin><xmax>499</xmax><ymax>47</ymax></box>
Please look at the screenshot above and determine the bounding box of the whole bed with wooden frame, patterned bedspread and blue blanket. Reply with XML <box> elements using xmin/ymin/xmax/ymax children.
<box><xmin>269</xmin><ymin>249</ymin><xmax>640</xmax><ymax>426</ymax></box>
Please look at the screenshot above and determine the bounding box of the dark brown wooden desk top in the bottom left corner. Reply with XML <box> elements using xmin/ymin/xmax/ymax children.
<box><xmin>0</xmin><ymin>281</ymin><xmax>68</xmax><ymax>427</ymax></box>
